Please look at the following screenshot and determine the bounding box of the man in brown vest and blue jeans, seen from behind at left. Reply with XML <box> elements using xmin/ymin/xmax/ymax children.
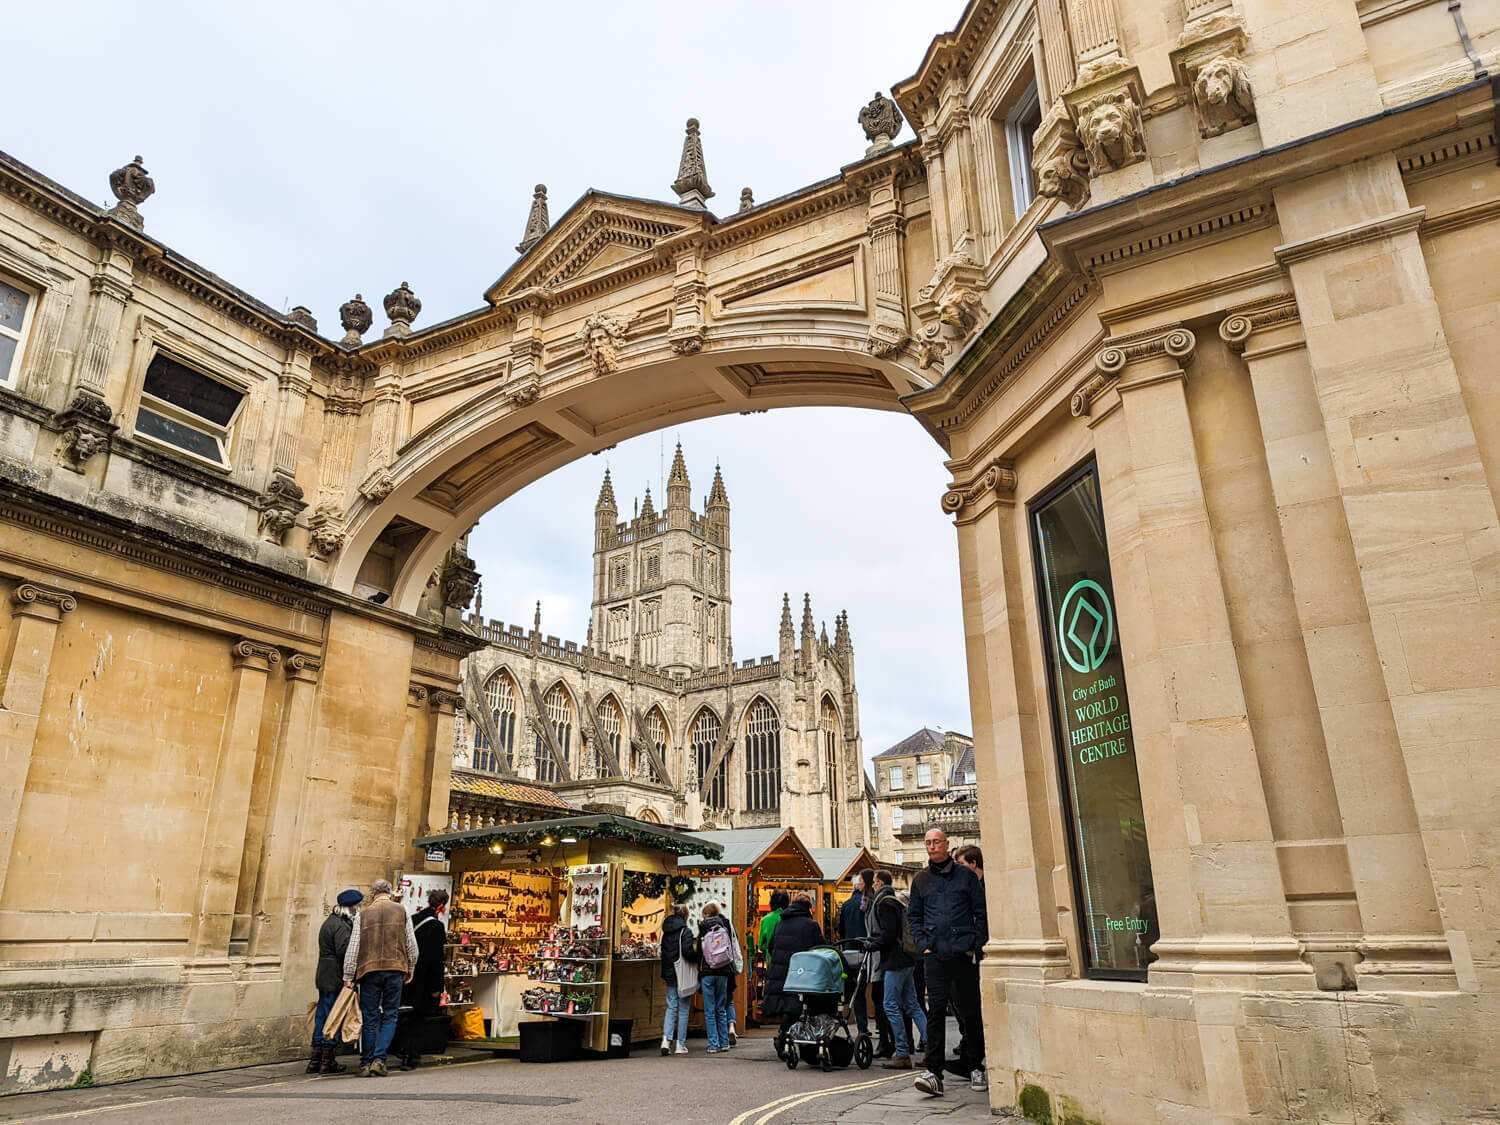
<box><xmin>344</xmin><ymin>879</ymin><xmax>420</xmax><ymax>1079</ymax></box>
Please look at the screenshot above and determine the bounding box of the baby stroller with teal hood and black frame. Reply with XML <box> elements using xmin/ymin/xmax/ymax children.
<box><xmin>776</xmin><ymin>938</ymin><xmax>875</xmax><ymax>1071</ymax></box>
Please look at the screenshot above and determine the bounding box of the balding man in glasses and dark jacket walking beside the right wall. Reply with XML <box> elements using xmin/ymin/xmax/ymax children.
<box><xmin>908</xmin><ymin>828</ymin><xmax>990</xmax><ymax>1097</ymax></box>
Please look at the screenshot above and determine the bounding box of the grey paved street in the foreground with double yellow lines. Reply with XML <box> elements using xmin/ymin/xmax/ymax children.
<box><xmin>0</xmin><ymin>1034</ymin><xmax>990</xmax><ymax>1125</ymax></box>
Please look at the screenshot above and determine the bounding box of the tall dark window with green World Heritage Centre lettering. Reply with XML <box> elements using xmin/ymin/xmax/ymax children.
<box><xmin>1031</xmin><ymin>465</ymin><xmax>1160</xmax><ymax>980</ymax></box>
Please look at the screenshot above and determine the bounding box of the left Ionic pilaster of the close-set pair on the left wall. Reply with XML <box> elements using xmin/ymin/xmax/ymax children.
<box><xmin>188</xmin><ymin>639</ymin><xmax>281</xmax><ymax>977</ymax></box>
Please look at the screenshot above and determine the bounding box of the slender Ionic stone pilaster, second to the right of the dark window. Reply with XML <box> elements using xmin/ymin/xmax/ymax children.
<box><xmin>1220</xmin><ymin>294</ymin><xmax>1457</xmax><ymax>992</ymax></box>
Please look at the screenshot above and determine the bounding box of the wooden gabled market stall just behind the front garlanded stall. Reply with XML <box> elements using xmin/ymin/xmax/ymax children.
<box><xmin>678</xmin><ymin>828</ymin><xmax>828</xmax><ymax>1026</ymax></box>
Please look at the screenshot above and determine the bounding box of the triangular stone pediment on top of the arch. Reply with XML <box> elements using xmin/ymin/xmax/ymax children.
<box><xmin>485</xmin><ymin>191</ymin><xmax>713</xmax><ymax>303</ymax></box>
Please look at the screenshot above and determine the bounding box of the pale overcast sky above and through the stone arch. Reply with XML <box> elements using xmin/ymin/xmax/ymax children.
<box><xmin>0</xmin><ymin>0</ymin><xmax>969</xmax><ymax>755</ymax></box>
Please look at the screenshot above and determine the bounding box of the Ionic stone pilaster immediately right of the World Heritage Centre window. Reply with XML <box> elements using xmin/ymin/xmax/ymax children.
<box><xmin>1076</xmin><ymin>327</ymin><xmax>1314</xmax><ymax>990</ymax></box>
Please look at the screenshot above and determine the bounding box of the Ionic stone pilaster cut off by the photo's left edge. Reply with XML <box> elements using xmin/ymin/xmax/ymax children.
<box><xmin>0</xmin><ymin>582</ymin><xmax>78</xmax><ymax>893</ymax></box>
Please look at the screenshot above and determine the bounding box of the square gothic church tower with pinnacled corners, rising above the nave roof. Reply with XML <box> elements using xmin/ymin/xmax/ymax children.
<box><xmin>591</xmin><ymin>444</ymin><xmax>732</xmax><ymax>675</ymax></box>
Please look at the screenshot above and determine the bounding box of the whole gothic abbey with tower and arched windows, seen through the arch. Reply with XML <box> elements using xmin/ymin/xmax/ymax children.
<box><xmin>452</xmin><ymin>447</ymin><xmax>869</xmax><ymax>848</ymax></box>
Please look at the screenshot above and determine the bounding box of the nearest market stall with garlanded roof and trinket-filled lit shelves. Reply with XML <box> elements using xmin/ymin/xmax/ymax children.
<box><xmin>414</xmin><ymin>815</ymin><xmax>717</xmax><ymax>1052</ymax></box>
